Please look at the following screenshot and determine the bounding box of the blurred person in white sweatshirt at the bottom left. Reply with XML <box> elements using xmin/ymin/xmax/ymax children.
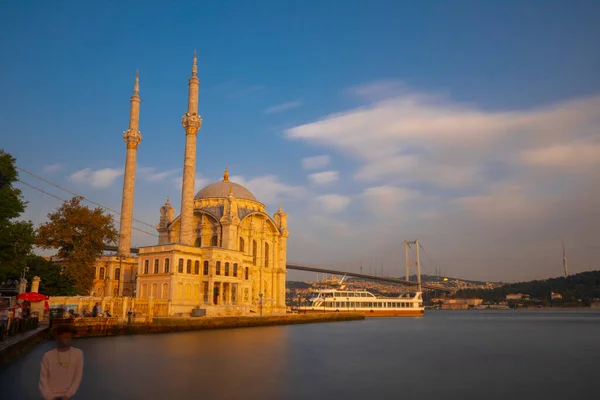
<box><xmin>39</xmin><ymin>326</ymin><xmax>83</xmax><ymax>400</ymax></box>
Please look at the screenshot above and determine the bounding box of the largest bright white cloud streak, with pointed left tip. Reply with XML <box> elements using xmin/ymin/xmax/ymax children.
<box><xmin>285</xmin><ymin>83</ymin><xmax>600</xmax><ymax>187</ymax></box>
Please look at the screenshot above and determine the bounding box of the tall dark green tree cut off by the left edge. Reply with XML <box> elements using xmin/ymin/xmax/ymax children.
<box><xmin>0</xmin><ymin>149</ymin><xmax>34</xmax><ymax>281</ymax></box>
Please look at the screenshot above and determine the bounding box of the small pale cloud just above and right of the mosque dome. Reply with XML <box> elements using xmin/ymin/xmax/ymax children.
<box><xmin>229</xmin><ymin>175</ymin><xmax>306</xmax><ymax>205</ymax></box>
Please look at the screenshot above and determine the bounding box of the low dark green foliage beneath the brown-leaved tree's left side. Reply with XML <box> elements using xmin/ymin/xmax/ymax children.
<box><xmin>25</xmin><ymin>255</ymin><xmax>77</xmax><ymax>296</ymax></box>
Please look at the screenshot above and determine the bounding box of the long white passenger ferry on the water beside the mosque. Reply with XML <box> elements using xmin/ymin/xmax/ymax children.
<box><xmin>298</xmin><ymin>289</ymin><xmax>425</xmax><ymax>317</ymax></box>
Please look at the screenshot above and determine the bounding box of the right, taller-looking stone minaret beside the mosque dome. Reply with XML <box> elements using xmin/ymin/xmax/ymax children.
<box><xmin>179</xmin><ymin>51</ymin><xmax>202</xmax><ymax>246</ymax></box>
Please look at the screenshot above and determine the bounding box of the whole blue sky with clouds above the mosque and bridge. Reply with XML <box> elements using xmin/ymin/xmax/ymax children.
<box><xmin>0</xmin><ymin>0</ymin><xmax>600</xmax><ymax>282</ymax></box>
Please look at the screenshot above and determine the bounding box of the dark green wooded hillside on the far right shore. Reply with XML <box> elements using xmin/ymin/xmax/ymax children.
<box><xmin>456</xmin><ymin>271</ymin><xmax>600</xmax><ymax>304</ymax></box>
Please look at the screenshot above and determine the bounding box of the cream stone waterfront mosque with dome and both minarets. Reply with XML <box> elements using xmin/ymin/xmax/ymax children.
<box><xmin>91</xmin><ymin>53</ymin><xmax>289</xmax><ymax>316</ymax></box>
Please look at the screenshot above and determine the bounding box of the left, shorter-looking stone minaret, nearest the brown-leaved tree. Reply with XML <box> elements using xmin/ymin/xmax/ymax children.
<box><xmin>118</xmin><ymin>71</ymin><xmax>142</xmax><ymax>255</ymax></box>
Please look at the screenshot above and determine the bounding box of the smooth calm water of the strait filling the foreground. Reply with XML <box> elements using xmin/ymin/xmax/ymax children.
<box><xmin>0</xmin><ymin>311</ymin><xmax>600</xmax><ymax>400</ymax></box>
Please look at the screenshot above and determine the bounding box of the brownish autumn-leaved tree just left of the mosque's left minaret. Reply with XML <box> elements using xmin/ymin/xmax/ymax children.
<box><xmin>36</xmin><ymin>197</ymin><xmax>117</xmax><ymax>295</ymax></box>
